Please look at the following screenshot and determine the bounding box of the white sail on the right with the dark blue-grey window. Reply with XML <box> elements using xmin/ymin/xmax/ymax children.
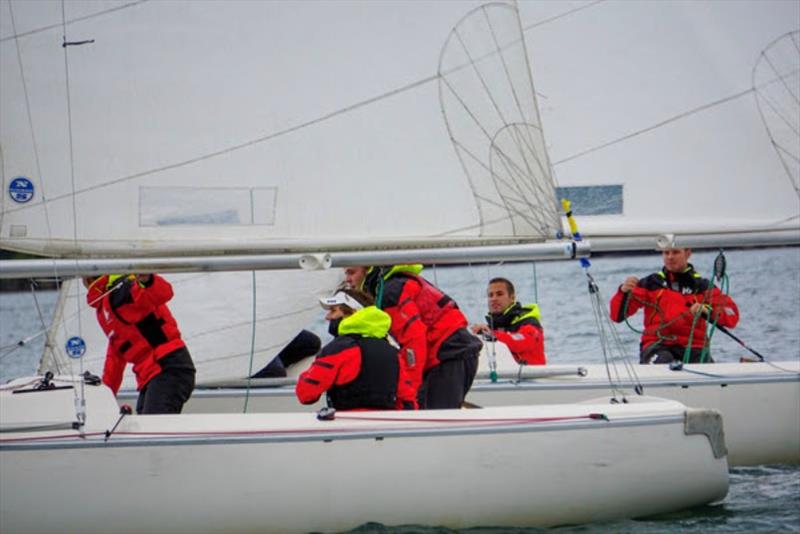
<box><xmin>520</xmin><ymin>1</ymin><xmax>800</xmax><ymax>244</ymax></box>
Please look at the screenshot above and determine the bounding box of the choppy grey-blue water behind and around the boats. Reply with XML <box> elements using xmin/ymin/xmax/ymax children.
<box><xmin>0</xmin><ymin>247</ymin><xmax>800</xmax><ymax>534</ymax></box>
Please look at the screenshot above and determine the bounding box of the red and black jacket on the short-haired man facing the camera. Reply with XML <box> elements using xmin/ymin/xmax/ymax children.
<box><xmin>486</xmin><ymin>302</ymin><xmax>547</xmax><ymax>365</ymax></box>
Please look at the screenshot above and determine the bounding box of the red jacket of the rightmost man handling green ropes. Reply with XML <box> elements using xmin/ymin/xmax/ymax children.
<box><xmin>610</xmin><ymin>265</ymin><xmax>739</xmax><ymax>350</ymax></box>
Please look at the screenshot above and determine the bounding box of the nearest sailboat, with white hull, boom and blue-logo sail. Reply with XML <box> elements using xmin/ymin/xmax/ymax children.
<box><xmin>0</xmin><ymin>1</ymin><xmax>752</xmax><ymax>532</ymax></box>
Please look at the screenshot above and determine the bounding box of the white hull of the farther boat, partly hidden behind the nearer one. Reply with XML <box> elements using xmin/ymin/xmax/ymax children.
<box><xmin>166</xmin><ymin>360</ymin><xmax>800</xmax><ymax>466</ymax></box>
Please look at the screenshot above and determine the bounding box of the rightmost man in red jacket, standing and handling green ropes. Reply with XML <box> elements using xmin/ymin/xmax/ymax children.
<box><xmin>610</xmin><ymin>248</ymin><xmax>739</xmax><ymax>363</ymax></box>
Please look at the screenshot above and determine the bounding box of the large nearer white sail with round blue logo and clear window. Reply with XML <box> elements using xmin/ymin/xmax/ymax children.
<box><xmin>0</xmin><ymin>1</ymin><xmax>559</xmax><ymax>256</ymax></box>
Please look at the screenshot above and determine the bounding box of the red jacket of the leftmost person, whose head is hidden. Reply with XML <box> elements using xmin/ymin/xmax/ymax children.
<box><xmin>86</xmin><ymin>274</ymin><xmax>185</xmax><ymax>395</ymax></box>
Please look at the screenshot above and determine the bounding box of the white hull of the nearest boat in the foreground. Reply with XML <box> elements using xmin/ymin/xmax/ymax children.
<box><xmin>0</xmin><ymin>378</ymin><xmax>728</xmax><ymax>533</ymax></box>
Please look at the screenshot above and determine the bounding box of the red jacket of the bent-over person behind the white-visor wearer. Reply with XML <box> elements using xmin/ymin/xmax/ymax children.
<box><xmin>380</xmin><ymin>266</ymin><xmax>467</xmax><ymax>376</ymax></box>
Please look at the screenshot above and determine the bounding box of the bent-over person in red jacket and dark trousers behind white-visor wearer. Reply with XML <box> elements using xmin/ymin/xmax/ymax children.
<box><xmin>345</xmin><ymin>264</ymin><xmax>482</xmax><ymax>409</ymax></box>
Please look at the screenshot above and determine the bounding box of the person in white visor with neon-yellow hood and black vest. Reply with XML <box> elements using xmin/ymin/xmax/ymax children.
<box><xmin>295</xmin><ymin>289</ymin><xmax>399</xmax><ymax>410</ymax></box>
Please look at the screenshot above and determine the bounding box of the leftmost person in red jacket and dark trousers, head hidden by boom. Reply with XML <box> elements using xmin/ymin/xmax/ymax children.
<box><xmin>83</xmin><ymin>274</ymin><xmax>195</xmax><ymax>414</ymax></box>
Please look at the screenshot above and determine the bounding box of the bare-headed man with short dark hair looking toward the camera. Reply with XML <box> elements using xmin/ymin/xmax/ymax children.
<box><xmin>470</xmin><ymin>278</ymin><xmax>547</xmax><ymax>365</ymax></box>
